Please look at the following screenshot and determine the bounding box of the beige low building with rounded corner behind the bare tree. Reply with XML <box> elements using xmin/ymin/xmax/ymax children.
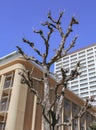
<box><xmin>0</xmin><ymin>52</ymin><xmax>96</xmax><ymax>130</ymax></box>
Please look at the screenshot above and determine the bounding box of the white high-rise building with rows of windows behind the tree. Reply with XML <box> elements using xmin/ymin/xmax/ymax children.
<box><xmin>54</xmin><ymin>44</ymin><xmax>96</xmax><ymax>105</ymax></box>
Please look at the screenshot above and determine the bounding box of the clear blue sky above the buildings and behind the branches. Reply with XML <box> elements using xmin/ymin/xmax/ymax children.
<box><xmin>0</xmin><ymin>0</ymin><xmax>96</xmax><ymax>61</ymax></box>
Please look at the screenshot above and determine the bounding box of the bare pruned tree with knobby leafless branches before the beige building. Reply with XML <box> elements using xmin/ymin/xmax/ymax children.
<box><xmin>17</xmin><ymin>12</ymin><xmax>93</xmax><ymax>130</ymax></box>
